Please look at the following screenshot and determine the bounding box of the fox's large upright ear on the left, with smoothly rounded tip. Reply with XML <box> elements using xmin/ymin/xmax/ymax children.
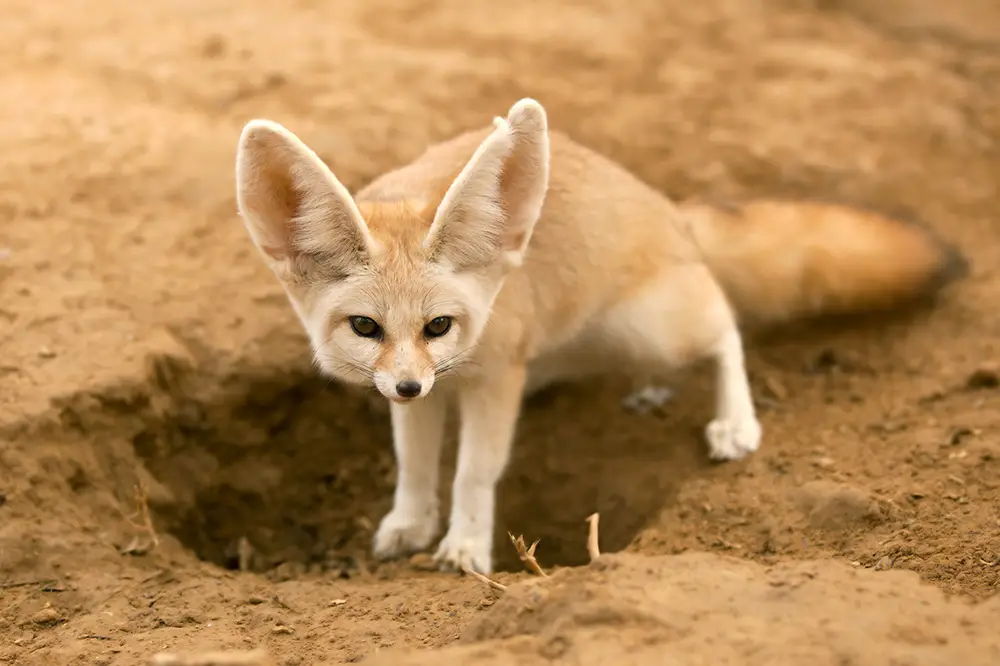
<box><xmin>236</xmin><ymin>120</ymin><xmax>375</xmax><ymax>275</ymax></box>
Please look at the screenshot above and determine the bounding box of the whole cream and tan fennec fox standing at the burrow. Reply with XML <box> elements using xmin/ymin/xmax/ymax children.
<box><xmin>236</xmin><ymin>99</ymin><xmax>961</xmax><ymax>573</ymax></box>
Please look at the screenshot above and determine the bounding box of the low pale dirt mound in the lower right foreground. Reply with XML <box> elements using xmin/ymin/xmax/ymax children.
<box><xmin>448</xmin><ymin>553</ymin><xmax>1000</xmax><ymax>665</ymax></box>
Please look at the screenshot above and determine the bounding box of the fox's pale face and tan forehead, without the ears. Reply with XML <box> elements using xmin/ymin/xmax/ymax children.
<box><xmin>292</xmin><ymin>202</ymin><xmax>502</xmax><ymax>401</ymax></box>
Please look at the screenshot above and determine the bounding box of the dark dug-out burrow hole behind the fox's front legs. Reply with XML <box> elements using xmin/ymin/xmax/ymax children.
<box><xmin>39</xmin><ymin>344</ymin><xmax>710</xmax><ymax>576</ymax></box>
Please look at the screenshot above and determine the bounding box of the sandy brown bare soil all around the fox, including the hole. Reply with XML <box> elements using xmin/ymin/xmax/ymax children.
<box><xmin>0</xmin><ymin>0</ymin><xmax>1000</xmax><ymax>666</ymax></box>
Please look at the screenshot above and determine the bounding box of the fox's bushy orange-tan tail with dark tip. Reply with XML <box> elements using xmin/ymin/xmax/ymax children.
<box><xmin>681</xmin><ymin>199</ymin><xmax>968</xmax><ymax>326</ymax></box>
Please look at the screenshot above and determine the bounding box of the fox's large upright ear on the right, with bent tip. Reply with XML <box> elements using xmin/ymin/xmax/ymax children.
<box><xmin>424</xmin><ymin>99</ymin><xmax>549</xmax><ymax>270</ymax></box>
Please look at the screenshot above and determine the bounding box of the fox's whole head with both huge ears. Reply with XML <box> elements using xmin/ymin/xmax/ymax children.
<box><xmin>236</xmin><ymin>99</ymin><xmax>549</xmax><ymax>402</ymax></box>
